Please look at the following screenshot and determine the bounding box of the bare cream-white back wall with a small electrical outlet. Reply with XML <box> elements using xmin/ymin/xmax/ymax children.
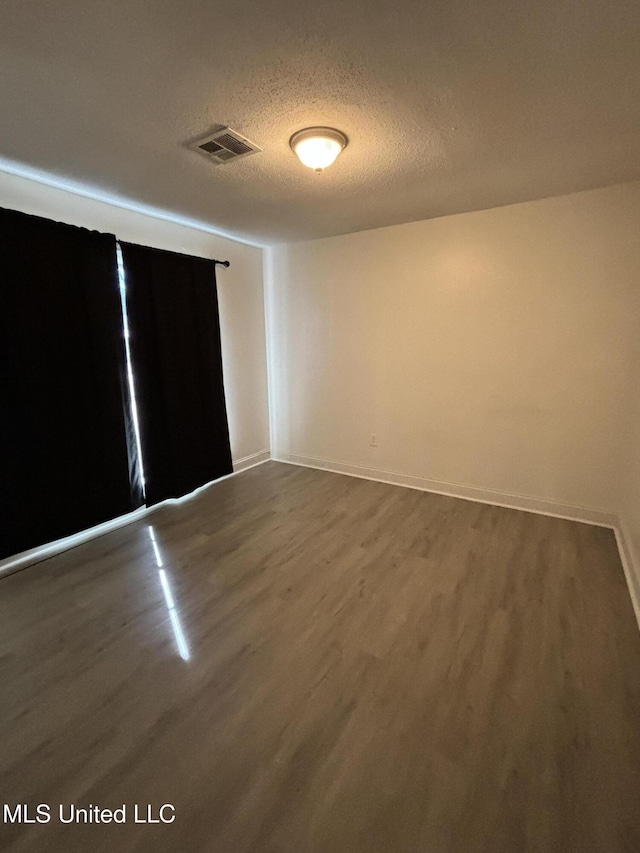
<box><xmin>266</xmin><ymin>184</ymin><xmax>640</xmax><ymax>529</ymax></box>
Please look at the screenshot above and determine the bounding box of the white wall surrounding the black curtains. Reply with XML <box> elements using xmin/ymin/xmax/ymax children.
<box><xmin>0</xmin><ymin>172</ymin><xmax>269</xmax><ymax>470</ymax></box>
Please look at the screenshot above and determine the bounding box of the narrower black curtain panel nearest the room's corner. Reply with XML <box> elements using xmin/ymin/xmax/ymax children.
<box><xmin>120</xmin><ymin>243</ymin><xmax>233</xmax><ymax>506</ymax></box>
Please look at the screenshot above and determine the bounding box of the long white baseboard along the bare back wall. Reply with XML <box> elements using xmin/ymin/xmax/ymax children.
<box><xmin>271</xmin><ymin>452</ymin><xmax>618</xmax><ymax>528</ymax></box>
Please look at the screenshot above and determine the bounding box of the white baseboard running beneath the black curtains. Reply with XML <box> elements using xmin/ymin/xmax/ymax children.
<box><xmin>0</xmin><ymin>450</ymin><xmax>271</xmax><ymax>578</ymax></box>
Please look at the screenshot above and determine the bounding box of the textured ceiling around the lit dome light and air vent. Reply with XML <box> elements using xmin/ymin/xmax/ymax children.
<box><xmin>0</xmin><ymin>0</ymin><xmax>640</xmax><ymax>244</ymax></box>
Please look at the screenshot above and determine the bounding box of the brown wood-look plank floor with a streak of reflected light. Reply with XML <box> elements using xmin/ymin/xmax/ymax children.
<box><xmin>0</xmin><ymin>462</ymin><xmax>640</xmax><ymax>853</ymax></box>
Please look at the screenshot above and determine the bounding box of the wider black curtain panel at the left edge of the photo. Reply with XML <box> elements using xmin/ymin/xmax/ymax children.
<box><xmin>0</xmin><ymin>209</ymin><xmax>134</xmax><ymax>557</ymax></box>
